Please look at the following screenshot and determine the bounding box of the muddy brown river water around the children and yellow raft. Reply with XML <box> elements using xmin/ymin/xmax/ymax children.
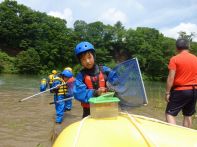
<box><xmin>0</xmin><ymin>75</ymin><xmax>196</xmax><ymax>147</ymax></box>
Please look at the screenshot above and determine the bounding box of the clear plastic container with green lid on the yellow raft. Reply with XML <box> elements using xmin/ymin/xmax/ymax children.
<box><xmin>89</xmin><ymin>92</ymin><xmax>120</xmax><ymax>118</ymax></box>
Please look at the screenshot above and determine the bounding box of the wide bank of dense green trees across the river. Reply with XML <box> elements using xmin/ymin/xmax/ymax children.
<box><xmin>0</xmin><ymin>0</ymin><xmax>197</xmax><ymax>80</ymax></box>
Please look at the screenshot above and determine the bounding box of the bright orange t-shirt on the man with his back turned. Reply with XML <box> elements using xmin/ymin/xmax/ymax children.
<box><xmin>168</xmin><ymin>51</ymin><xmax>197</xmax><ymax>90</ymax></box>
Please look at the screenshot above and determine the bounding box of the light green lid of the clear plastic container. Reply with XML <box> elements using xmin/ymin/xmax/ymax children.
<box><xmin>89</xmin><ymin>92</ymin><xmax>120</xmax><ymax>104</ymax></box>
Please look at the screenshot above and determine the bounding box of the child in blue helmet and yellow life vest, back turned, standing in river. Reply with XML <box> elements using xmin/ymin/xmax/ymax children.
<box><xmin>52</xmin><ymin>70</ymin><xmax>73</xmax><ymax>123</ymax></box>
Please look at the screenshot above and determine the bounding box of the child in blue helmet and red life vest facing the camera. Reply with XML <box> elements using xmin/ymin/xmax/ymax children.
<box><xmin>73</xmin><ymin>42</ymin><xmax>111</xmax><ymax>118</ymax></box>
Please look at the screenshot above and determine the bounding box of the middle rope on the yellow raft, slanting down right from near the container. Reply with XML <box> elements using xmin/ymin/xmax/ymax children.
<box><xmin>121</xmin><ymin>111</ymin><xmax>157</xmax><ymax>147</ymax></box>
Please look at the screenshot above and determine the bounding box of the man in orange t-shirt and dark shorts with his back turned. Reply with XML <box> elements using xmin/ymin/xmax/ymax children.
<box><xmin>165</xmin><ymin>38</ymin><xmax>197</xmax><ymax>128</ymax></box>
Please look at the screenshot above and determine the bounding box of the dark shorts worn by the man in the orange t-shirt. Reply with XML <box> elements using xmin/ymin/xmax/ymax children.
<box><xmin>166</xmin><ymin>90</ymin><xmax>197</xmax><ymax>116</ymax></box>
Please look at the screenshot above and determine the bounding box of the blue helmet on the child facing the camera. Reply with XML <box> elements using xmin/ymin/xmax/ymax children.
<box><xmin>75</xmin><ymin>41</ymin><xmax>95</xmax><ymax>56</ymax></box>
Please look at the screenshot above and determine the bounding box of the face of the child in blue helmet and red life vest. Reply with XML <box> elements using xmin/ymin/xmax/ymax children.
<box><xmin>80</xmin><ymin>52</ymin><xmax>94</xmax><ymax>69</ymax></box>
